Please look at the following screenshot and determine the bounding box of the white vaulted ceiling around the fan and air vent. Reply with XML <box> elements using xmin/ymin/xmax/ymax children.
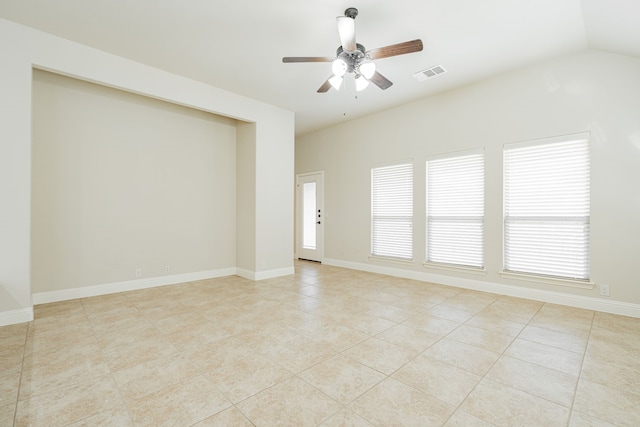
<box><xmin>0</xmin><ymin>0</ymin><xmax>640</xmax><ymax>134</ymax></box>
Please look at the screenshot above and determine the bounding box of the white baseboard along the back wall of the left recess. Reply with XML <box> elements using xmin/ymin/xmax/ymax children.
<box><xmin>32</xmin><ymin>267</ymin><xmax>236</xmax><ymax>305</ymax></box>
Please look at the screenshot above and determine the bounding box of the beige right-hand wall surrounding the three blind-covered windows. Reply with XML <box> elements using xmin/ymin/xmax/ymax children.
<box><xmin>296</xmin><ymin>51</ymin><xmax>640</xmax><ymax>316</ymax></box>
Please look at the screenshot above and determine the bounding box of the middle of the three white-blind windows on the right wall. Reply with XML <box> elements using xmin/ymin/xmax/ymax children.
<box><xmin>426</xmin><ymin>150</ymin><xmax>484</xmax><ymax>268</ymax></box>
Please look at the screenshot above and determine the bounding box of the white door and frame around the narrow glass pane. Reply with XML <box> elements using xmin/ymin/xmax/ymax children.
<box><xmin>295</xmin><ymin>170</ymin><xmax>326</xmax><ymax>262</ymax></box>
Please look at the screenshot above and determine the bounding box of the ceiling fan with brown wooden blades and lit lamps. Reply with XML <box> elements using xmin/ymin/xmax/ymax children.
<box><xmin>282</xmin><ymin>7</ymin><xmax>422</xmax><ymax>93</ymax></box>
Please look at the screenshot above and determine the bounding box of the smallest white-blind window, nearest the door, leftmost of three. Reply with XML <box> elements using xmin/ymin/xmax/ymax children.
<box><xmin>371</xmin><ymin>163</ymin><xmax>413</xmax><ymax>260</ymax></box>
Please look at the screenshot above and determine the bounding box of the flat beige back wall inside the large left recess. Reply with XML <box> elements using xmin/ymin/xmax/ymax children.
<box><xmin>31</xmin><ymin>70</ymin><xmax>236</xmax><ymax>293</ymax></box>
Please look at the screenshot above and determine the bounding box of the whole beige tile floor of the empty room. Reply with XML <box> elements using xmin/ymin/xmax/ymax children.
<box><xmin>0</xmin><ymin>262</ymin><xmax>640</xmax><ymax>427</ymax></box>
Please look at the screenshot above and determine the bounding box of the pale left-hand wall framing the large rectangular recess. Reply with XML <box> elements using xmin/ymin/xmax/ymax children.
<box><xmin>0</xmin><ymin>18</ymin><xmax>294</xmax><ymax>325</ymax></box>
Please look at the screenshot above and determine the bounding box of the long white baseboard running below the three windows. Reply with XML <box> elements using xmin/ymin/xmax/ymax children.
<box><xmin>323</xmin><ymin>258</ymin><xmax>640</xmax><ymax>318</ymax></box>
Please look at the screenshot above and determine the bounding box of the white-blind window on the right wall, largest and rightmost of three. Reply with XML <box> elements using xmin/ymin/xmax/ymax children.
<box><xmin>504</xmin><ymin>134</ymin><xmax>590</xmax><ymax>280</ymax></box>
